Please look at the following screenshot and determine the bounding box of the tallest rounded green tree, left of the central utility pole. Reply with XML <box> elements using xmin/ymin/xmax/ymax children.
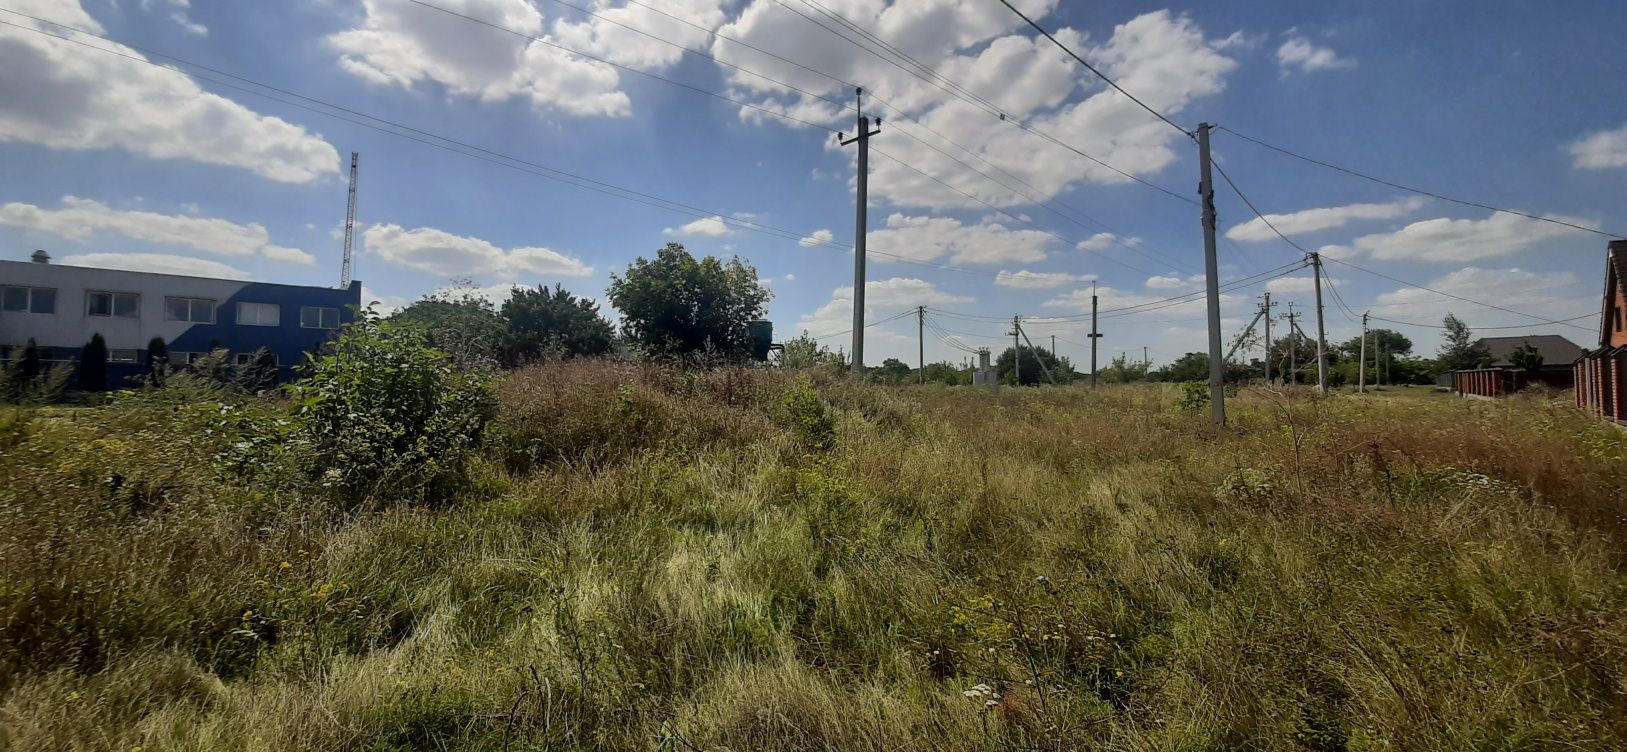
<box><xmin>608</xmin><ymin>243</ymin><xmax>770</xmax><ymax>355</ymax></box>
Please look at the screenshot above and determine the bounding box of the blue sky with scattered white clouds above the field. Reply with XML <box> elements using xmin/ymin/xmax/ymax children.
<box><xmin>0</xmin><ymin>0</ymin><xmax>1627</xmax><ymax>366</ymax></box>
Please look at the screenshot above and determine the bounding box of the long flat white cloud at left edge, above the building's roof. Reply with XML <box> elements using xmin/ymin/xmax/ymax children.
<box><xmin>0</xmin><ymin>195</ymin><xmax>270</xmax><ymax>256</ymax></box>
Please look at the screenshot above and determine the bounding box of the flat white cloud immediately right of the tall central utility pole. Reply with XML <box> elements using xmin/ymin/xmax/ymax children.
<box><xmin>866</xmin><ymin>213</ymin><xmax>1051</xmax><ymax>264</ymax></box>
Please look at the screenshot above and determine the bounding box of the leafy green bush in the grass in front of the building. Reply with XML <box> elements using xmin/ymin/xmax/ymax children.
<box><xmin>291</xmin><ymin>311</ymin><xmax>495</xmax><ymax>498</ymax></box>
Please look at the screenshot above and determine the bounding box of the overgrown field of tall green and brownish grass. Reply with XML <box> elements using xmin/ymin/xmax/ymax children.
<box><xmin>0</xmin><ymin>363</ymin><xmax>1627</xmax><ymax>750</ymax></box>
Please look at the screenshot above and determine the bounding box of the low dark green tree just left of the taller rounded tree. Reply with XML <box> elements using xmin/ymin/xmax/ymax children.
<box><xmin>501</xmin><ymin>285</ymin><xmax>615</xmax><ymax>361</ymax></box>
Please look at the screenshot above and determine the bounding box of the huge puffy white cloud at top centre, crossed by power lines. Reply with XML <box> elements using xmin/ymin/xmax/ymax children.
<box><xmin>711</xmin><ymin>7</ymin><xmax>1237</xmax><ymax>208</ymax></box>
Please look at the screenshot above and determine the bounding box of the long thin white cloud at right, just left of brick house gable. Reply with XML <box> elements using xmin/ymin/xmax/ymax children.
<box><xmin>1323</xmin><ymin>212</ymin><xmax>1596</xmax><ymax>262</ymax></box>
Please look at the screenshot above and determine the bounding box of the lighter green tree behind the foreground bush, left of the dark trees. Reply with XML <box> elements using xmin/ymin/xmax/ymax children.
<box><xmin>390</xmin><ymin>280</ymin><xmax>509</xmax><ymax>369</ymax></box>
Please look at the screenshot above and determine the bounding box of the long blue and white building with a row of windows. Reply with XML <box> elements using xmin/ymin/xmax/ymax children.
<box><xmin>0</xmin><ymin>251</ymin><xmax>361</xmax><ymax>387</ymax></box>
